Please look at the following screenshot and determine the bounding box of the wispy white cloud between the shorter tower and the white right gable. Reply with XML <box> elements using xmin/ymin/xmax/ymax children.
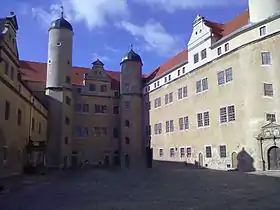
<box><xmin>119</xmin><ymin>20</ymin><xmax>184</xmax><ymax>56</ymax></box>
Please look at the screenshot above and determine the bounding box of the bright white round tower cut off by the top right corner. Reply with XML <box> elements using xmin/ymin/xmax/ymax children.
<box><xmin>249</xmin><ymin>0</ymin><xmax>280</xmax><ymax>23</ymax></box>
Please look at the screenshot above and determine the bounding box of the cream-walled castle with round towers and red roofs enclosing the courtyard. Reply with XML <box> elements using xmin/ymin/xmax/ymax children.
<box><xmin>0</xmin><ymin>0</ymin><xmax>280</xmax><ymax>177</ymax></box>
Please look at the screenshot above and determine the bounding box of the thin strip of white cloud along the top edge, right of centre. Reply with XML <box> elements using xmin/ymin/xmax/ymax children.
<box><xmin>133</xmin><ymin>0</ymin><xmax>248</xmax><ymax>13</ymax></box>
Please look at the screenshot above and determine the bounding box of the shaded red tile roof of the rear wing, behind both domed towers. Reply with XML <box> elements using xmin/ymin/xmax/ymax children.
<box><xmin>20</xmin><ymin>61</ymin><xmax>120</xmax><ymax>90</ymax></box>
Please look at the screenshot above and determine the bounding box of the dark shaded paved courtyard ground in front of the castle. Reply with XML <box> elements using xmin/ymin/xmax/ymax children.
<box><xmin>0</xmin><ymin>164</ymin><xmax>280</xmax><ymax>210</ymax></box>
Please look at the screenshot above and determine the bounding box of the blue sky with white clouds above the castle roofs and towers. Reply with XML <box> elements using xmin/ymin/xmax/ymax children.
<box><xmin>0</xmin><ymin>0</ymin><xmax>247</xmax><ymax>73</ymax></box>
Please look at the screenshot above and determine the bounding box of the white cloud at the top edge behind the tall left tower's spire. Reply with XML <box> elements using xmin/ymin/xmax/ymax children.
<box><xmin>32</xmin><ymin>0</ymin><xmax>129</xmax><ymax>29</ymax></box>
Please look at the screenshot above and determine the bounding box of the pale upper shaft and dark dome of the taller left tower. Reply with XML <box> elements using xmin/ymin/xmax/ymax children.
<box><xmin>46</xmin><ymin>12</ymin><xmax>73</xmax><ymax>88</ymax></box>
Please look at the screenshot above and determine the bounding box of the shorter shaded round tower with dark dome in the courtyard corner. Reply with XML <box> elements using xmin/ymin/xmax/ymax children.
<box><xmin>120</xmin><ymin>48</ymin><xmax>145</xmax><ymax>168</ymax></box>
